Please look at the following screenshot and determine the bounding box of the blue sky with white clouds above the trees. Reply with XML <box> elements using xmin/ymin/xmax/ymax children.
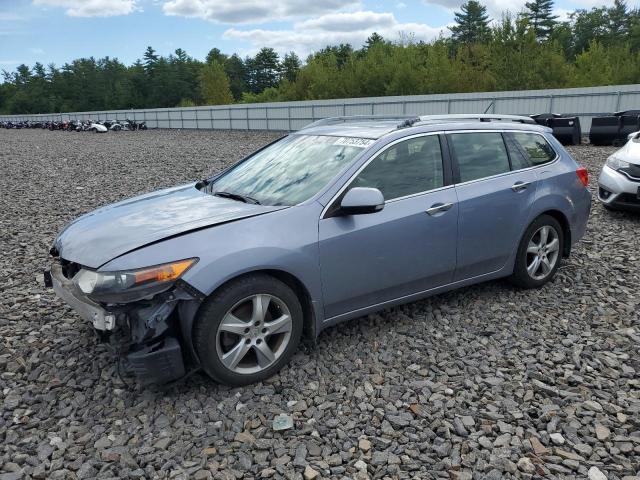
<box><xmin>0</xmin><ymin>0</ymin><xmax>640</xmax><ymax>70</ymax></box>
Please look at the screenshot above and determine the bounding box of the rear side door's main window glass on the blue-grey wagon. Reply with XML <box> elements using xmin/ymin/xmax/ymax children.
<box><xmin>449</xmin><ymin>132</ymin><xmax>510</xmax><ymax>182</ymax></box>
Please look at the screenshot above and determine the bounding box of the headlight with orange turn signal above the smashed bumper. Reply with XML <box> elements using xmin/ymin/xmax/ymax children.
<box><xmin>73</xmin><ymin>258</ymin><xmax>198</xmax><ymax>303</ymax></box>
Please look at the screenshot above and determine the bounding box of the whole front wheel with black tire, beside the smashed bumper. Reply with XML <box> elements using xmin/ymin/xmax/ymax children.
<box><xmin>193</xmin><ymin>274</ymin><xmax>303</xmax><ymax>386</ymax></box>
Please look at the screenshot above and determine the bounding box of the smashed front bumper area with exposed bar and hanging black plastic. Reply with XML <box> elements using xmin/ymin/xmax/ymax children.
<box><xmin>45</xmin><ymin>263</ymin><xmax>202</xmax><ymax>384</ymax></box>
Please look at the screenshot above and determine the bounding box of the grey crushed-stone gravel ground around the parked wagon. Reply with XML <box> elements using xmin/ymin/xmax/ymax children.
<box><xmin>0</xmin><ymin>130</ymin><xmax>640</xmax><ymax>480</ymax></box>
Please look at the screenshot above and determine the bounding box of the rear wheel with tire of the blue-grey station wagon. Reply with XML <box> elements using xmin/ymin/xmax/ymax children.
<box><xmin>510</xmin><ymin>215</ymin><xmax>564</xmax><ymax>288</ymax></box>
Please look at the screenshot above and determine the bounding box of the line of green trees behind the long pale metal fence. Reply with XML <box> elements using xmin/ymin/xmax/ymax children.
<box><xmin>0</xmin><ymin>0</ymin><xmax>640</xmax><ymax>113</ymax></box>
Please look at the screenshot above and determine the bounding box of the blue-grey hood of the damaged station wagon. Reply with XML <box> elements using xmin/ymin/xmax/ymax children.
<box><xmin>53</xmin><ymin>184</ymin><xmax>286</xmax><ymax>268</ymax></box>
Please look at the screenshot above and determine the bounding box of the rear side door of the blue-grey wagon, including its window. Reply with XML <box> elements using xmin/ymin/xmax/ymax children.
<box><xmin>447</xmin><ymin>131</ymin><xmax>537</xmax><ymax>281</ymax></box>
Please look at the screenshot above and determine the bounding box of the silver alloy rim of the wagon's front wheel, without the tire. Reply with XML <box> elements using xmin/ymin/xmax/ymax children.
<box><xmin>216</xmin><ymin>294</ymin><xmax>293</xmax><ymax>375</ymax></box>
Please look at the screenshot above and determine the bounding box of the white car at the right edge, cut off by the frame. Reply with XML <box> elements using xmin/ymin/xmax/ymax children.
<box><xmin>598</xmin><ymin>132</ymin><xmax>640</xmax><ymax>211</ymax></box>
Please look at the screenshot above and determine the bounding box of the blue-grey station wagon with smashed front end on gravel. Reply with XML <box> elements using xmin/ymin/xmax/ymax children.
<box><xmin>45</xmin><ymin>115</ymin><xmax>591</xmax><ymax>385</ymax></box>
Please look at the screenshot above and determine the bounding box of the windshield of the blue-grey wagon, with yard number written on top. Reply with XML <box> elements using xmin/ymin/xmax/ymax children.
<box><xmin>208</xmin><ymin>135</ymin><xmax>373</xmax><ymax>205</ymax></box>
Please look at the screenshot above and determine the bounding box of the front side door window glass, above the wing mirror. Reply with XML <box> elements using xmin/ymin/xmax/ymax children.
<box><xmin>351</xmin><ymin>135</ymin><xmax>444</xmax><ymax>200</ymax></box>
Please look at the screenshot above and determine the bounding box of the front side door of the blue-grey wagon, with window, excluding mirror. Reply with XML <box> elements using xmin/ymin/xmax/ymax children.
<box><xmin>319</xmin><ymin>134</ymin><xmax>458</xmax><ymax>318</ymax></box>
